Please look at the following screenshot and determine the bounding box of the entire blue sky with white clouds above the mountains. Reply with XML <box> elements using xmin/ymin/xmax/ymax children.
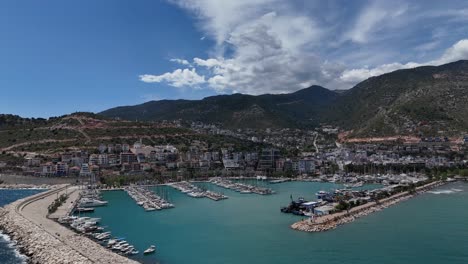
<box><xmin>0</xmin><ymin>0</ymin><xmax>468</xmax><ymax>117</ymax></box>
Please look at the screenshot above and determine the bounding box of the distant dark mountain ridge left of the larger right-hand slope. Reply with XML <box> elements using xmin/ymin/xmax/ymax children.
<box><xmin>100</xmin><ymin>86</ymin><xmax>338</xmax><ymax>128</ymax></box>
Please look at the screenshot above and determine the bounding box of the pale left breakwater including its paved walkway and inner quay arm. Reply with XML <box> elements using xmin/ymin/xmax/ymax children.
<box><xmin>0</xmin><ymin>185</ymin><xmax>137</xmax><ymax>263</ymax></box>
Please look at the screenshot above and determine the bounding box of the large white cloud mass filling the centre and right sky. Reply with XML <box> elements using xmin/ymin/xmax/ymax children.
<box><xmin>140</xmin><ymin>0</ymin><xmax>468</xmax><ymax>94</ymax></box>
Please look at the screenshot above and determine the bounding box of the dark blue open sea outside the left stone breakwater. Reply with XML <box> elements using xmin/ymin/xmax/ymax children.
<box><xmin>0</xmin><ymin>189</ymin><xmax>43</xmax><ymax>264</ymax></box>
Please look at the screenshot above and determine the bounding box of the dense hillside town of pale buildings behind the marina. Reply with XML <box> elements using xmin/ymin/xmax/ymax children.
<box><xmin>4</xmin><ymin>126</ymin><xmax>468</xmax><ymax>184</ymax></box>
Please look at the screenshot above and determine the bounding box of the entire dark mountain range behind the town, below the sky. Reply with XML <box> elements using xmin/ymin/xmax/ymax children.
<box><xmin>99</xmin><ymin>60</ymin><xmax>468</xmax><ymax>136</ymax></box>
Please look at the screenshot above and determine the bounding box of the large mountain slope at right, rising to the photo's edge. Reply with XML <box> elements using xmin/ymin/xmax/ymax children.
<box><xmin>328</xmin><ymin>61</ymin><xmax>468</xmax><ymax>136</ymax></box>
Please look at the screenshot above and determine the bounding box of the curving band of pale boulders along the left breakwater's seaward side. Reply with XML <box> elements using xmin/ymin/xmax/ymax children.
<box><xmin>0</xmin><ymin>187</ymin><xmax>138</xmax><ymax>264</ymax></box>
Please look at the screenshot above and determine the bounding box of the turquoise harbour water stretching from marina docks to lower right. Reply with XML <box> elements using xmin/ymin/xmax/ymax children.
<box><xmin>85</xmin><ymin>182</ymin><xmax>468</xmax><ymax>264</ymax></box>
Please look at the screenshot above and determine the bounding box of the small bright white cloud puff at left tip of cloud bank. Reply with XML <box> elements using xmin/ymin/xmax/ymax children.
<box><xmin>140</xmin><ymin>69</ymin><xmax>206</xmax><ymax>88</ymax></box>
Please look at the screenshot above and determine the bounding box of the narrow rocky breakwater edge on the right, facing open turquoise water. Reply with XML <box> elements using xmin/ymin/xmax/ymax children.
<box><xmin>291</xmin><ymin>182</ymin><xmax>446</xmax><ymax>232</ymax></box>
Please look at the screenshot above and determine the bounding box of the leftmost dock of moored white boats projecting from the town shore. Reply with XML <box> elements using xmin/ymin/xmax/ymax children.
<box><xmin>124</xmin><ymin>186</ymin><xmax>174</xmax><ymax>211</ymax></box>
